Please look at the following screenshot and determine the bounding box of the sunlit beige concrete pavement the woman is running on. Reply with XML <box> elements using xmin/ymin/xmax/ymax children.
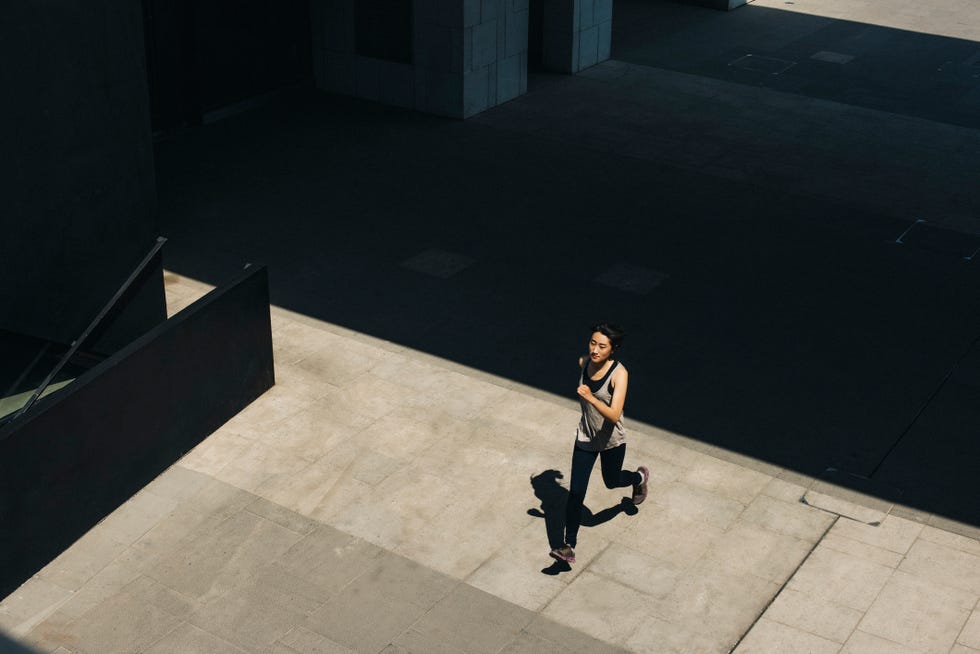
<box><xmin>0</xmin><ymin>273</ymin><xmax>980</xmax><ymax>654</ymax></box>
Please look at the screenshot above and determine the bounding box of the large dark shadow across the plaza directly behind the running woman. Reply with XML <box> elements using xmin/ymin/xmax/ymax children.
<box><xmin>156</xmin><ymin>3</ymin><xmax>980</xmax><ymax>525</ymax></box>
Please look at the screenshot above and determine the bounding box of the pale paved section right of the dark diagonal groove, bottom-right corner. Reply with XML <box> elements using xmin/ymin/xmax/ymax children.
<box><xmin>735</xmin><ymin>516</ymin><xmax>980</xmax><ymax>652</ymax></box>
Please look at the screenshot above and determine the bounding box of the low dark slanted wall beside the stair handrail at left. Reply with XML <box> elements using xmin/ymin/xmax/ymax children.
<box><xmin>0</xmin><ymin>267</ymin><xmax>275</xmax><ymax>600</ymax></box>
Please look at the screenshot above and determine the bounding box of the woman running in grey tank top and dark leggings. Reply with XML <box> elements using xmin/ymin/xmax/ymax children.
<box><xmin>551</xmin><ymin>323</ymin><xmax>650</xmax><ymax>563</ymax></box>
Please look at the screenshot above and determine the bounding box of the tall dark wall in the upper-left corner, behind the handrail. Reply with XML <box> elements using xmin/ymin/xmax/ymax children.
<box><xmin>0</xmin><ymin>0</ymin><xmax>166</xmax><ymax>354</ymax></box>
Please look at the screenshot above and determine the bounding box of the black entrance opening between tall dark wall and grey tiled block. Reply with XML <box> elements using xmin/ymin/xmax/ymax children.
<box><xmin>142</xmin><ymin>0</ymin><xmax>313</xmax><ymax>130</ymax></box>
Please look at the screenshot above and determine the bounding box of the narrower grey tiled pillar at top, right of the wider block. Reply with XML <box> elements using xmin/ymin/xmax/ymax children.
<box><xmin>542</xmin><ymin>0</ymin><xmax>612</xmax><ymax>73</ymax></box>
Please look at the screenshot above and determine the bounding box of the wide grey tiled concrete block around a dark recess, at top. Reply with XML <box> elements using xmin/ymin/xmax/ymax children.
<box><xmin>313</xmin><ymin>0</ymin><xmax>528</xmax><ymax>118</ymax></box>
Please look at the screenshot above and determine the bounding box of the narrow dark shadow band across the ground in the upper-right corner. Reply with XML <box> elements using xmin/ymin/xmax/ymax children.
<box><xmin>612</xmin><ymin>0</ymin><xmax>980</xmax><ymax>127</ymax></box>
